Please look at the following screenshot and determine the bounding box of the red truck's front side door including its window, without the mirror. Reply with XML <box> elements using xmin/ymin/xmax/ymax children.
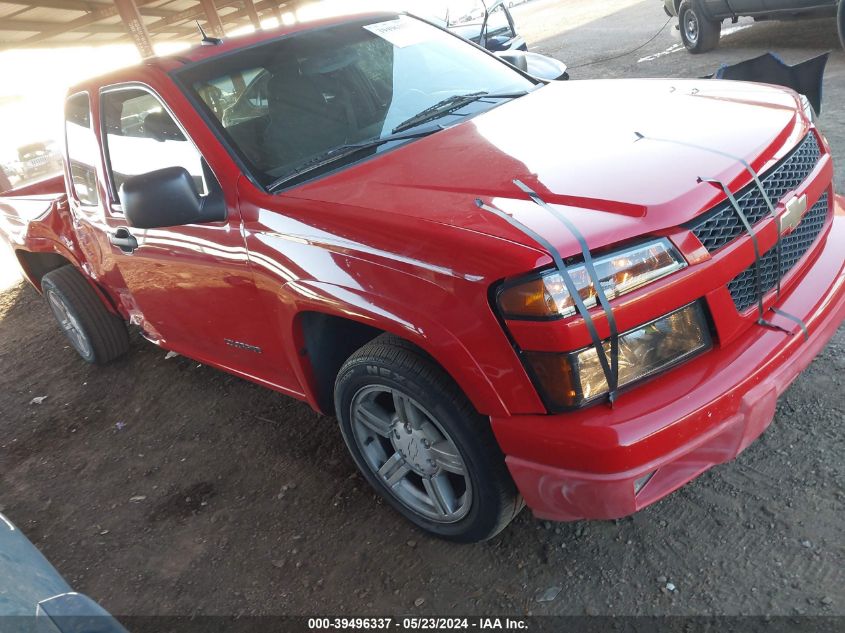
<box><xmin>93</xmin><ymin>85</ymin><xmax>289</xmax><ymax>384</ymax></box>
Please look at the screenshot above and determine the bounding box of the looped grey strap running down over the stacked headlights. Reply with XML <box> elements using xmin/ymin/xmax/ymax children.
<box><xmin>475</xmin><ymin>180</ymin><xmax>619</xmax><ymax>406</ymax></box>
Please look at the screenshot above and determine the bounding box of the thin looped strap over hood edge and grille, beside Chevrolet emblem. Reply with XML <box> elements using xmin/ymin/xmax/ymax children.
<box><xmin>634</xmin><ymin>132</ymin><xmax>810</xmax><ymax>340</ymax></box>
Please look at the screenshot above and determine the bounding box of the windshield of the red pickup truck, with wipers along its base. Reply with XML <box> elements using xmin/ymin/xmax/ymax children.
<box><xmin>178</xmin><ymin>16</ymin><xmax>535</xmax><ymax>186</ymax></box>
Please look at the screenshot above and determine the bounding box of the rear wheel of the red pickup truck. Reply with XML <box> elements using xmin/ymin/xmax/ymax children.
<box><xmin>41</xmin><ymin>266</ymin><xmax>129</xmax><ymax>365</ymax></box>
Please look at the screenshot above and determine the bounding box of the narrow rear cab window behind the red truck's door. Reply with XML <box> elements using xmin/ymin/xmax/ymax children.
<box><xmin>65</xmin><ymin>93</ymin><xmax>100</xmax><ymax>205</ymax></box>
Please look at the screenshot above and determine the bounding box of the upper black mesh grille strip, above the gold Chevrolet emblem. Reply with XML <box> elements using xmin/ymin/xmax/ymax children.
<box><xmin>687</xmin><ymin>132</ymin><xmax>821</xmax><ymax>253</ymax></box>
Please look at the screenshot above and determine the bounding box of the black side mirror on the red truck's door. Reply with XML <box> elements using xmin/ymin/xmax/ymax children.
<box><xmin>120</xmin><ymin>167</ymin><xmax>226</xmax><ymax>229</ymax></box>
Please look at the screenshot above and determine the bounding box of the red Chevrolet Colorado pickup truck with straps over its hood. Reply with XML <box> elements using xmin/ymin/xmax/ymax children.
<box><xmin>0</xmin><ymin>14</ymin><xmax>845</xmax><ymax>541</ymax></box>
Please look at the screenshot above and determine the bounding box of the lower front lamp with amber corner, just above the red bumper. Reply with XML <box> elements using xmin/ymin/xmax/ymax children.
<box><xmin>525</xmin><ymin>303</ymin><xmax>713</xmax><ymax>411</ymax></box>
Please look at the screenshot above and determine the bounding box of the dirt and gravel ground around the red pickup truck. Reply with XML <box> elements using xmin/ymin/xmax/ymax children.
<box><xmin>0</xmin><ymin>0</ymin><xmax>845</xmax><ymax>615</ymax></box>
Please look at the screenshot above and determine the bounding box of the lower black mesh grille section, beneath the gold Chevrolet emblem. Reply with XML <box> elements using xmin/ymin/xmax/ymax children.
<box><xmin>728</xmin><ymin>192</ymin><xmax>829</xmax><ymax>312</ymax></box>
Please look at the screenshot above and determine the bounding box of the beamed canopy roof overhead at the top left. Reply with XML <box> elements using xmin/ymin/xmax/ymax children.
<box><xmin>0</xmin><ymin>0</ymin><xmax>304</xmax><ymax>57</ymax></box>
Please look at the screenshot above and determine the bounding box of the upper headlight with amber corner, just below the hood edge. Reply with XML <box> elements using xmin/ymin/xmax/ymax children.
<box><xmin>498</xmin><ymin>239</ymin><xmax>686</xmax><ymax>319</ymax></box>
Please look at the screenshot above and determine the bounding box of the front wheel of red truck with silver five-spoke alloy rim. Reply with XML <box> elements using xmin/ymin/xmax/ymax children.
<box><xmin>335</xmin><ymin>335</ymin><xmax>523</xmax><ymax>543</ymax></box>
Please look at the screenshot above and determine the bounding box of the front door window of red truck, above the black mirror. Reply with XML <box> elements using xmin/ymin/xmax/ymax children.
<box><xmin>102</xmin><ymin>88</ymin><xmax>208</xmax><ymax>196</ymax></box>
